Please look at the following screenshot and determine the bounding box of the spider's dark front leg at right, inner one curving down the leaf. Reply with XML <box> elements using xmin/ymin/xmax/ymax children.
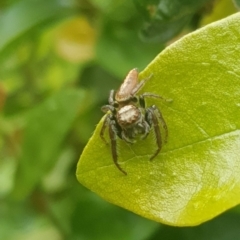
<box><xmin>146</xmin><ymin>105</ymin><xmax>162</xmax><ymax>161</ymax></box>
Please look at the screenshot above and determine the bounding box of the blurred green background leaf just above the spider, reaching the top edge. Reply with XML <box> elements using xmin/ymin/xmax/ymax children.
<box><xmin>96</xmin><ymin>0</ymin><xmax>164</xmax><ymax>78</ymax></box>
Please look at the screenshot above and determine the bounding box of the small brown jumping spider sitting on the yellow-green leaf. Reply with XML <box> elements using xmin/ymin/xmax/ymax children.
<box><xmin>100</xmin><ymin>68</ymin><xmax>168</xmax><ymax>175</ymax></box>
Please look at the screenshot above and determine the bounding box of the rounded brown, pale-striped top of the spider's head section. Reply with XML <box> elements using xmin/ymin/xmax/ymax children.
<box><xmin>117</xmin><ymin>105</ymin><xmax>142</xmax><ymax>128</ymax></box>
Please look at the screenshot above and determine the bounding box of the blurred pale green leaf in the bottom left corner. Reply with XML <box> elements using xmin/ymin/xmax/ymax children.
<box><xmin>0</xmin><ymin>200</ymin><xmax>61</xmax><ymax>240</ymax></box>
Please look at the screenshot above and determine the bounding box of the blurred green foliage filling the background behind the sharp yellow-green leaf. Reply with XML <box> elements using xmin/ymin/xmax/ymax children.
<box><xmin>0</xmin><ymin>0</ymin><xmax>240</xmax><ymax>240</ymax></box>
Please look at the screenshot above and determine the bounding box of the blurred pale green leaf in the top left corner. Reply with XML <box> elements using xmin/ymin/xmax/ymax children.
<box><xmin>0</xmin><ymin>0</ymin><xmax>73</xmax><ymax>56</ymax></box>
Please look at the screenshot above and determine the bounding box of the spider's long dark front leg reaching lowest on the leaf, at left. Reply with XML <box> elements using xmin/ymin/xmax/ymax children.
<box><xmin>109</xmin><ymin>120</ymin><xmax>127</xmax><ymax>175</ymax></box>
